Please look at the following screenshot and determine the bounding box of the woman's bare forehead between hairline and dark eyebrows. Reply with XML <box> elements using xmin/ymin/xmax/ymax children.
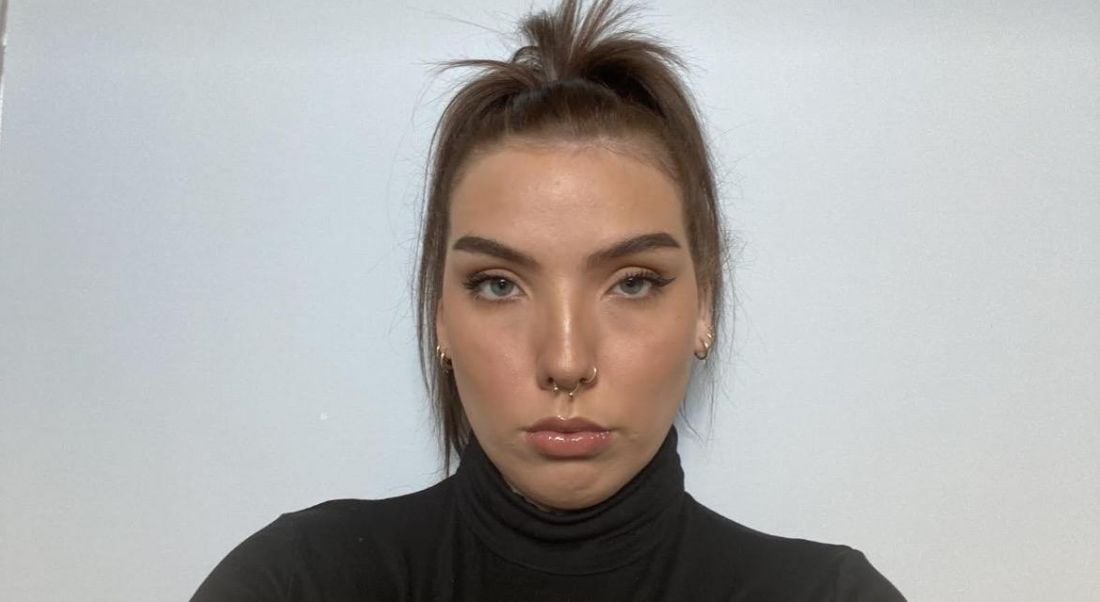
<box><xmin>450</xmin><ymin>142</ymin><xmax>686</xmax><ymax>247</ymax></box>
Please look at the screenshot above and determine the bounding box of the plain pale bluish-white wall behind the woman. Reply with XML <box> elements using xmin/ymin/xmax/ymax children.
<box><xmin>0</xmin><ymin>0</ymin><xmax>1100</xmax><ymax>602</ymax></box>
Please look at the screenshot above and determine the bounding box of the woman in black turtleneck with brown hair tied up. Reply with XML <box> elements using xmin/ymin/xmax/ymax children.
<box><xmin>194</xmin><ymin>0</ymin><xmax>902</xmax><ymax>602</ymax></box>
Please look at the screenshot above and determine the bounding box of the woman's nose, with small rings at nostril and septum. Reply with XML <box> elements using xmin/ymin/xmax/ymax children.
<box><xmin>535</xmin><ymin>296</ymin><xmax>596</xmax><ymax>394</ymax></box>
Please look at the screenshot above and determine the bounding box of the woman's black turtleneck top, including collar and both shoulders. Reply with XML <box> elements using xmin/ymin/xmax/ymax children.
<box><xmin>191</xmin><ymin>428</ymin><xmax>904</xmax><ymax>602</ymax></box>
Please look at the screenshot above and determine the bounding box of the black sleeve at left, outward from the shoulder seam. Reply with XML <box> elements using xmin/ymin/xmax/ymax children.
<box><xmin>191</xmin><ymin>515</ymin><xmax>300</xmax><ymax>602</ymax></box>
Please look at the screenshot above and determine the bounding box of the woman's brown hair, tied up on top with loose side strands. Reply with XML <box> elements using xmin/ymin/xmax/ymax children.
<box><xmin>416</xmin><ymin>0</ymin><xmax>726</xmax><ymax>474</ymax></box>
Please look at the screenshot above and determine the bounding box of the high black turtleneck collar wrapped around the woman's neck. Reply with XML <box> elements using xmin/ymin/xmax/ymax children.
<box><xmin>454</xmin><ymin>427</ymin><xmax>684</xmax><ymax>574</ymax></box>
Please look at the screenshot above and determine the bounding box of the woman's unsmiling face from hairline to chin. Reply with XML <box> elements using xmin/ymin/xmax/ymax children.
<box><xmin>436</xmin><ymin>142</ymin><xmax>710</xmax><ymax>510</ymax></box>
